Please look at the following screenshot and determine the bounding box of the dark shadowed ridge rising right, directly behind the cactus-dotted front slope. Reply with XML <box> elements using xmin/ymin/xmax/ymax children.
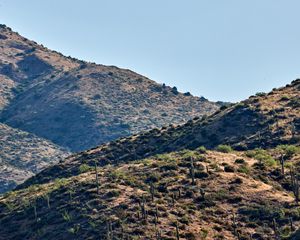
<box><xmin>19</xmin><ymin>80</ymin><xmax>300</xmax><ymax>185</ymax></box>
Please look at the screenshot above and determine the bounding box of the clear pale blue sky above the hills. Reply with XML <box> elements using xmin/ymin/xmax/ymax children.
<box><xmin>0</xmin><ymin>0</ymin><xmax>300</xmax><ymax>101</ymax></box>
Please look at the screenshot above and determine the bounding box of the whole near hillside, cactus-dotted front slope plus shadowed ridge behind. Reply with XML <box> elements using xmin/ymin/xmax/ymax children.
<box><xmin>0</xmin><ymin>80</ymin><xmax>300</xmax><ymax>240</ymax></box>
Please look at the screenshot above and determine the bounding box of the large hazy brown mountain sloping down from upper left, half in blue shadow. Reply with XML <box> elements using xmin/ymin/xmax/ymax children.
<box><xmin>0</xmin><ymin>25</ymin><xmax>220</xmax><ymax>151</ymax></box>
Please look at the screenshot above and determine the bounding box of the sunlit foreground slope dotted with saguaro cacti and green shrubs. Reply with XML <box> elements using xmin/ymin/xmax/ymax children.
<box><xmin>0</xmin><ymin>148</ymin><xmax>300</xmax><ymax>240</ymax></box>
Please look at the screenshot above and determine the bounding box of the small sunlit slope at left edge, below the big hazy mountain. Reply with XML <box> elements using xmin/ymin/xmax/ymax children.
<box><xmin>0</xmin><ymin>123</ymin><xmax>68</xmax><ymax>194</ymax></box>
